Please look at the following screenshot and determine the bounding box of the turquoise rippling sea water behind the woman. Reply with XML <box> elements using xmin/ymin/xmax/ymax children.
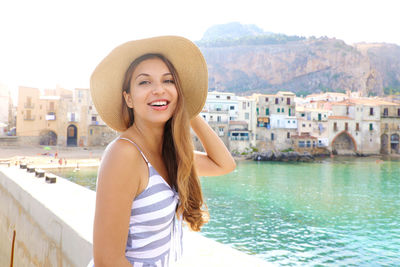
<box><xmin>50</xmin><ymin>157</ymin><xmax>400</xmax><ymax>266</ymax></box>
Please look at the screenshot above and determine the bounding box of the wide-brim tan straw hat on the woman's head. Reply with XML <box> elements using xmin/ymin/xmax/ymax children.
<box><xmin>90</xmin><ymin>36</ymin><xmax>208</xmax><ymax>132</ymax></box>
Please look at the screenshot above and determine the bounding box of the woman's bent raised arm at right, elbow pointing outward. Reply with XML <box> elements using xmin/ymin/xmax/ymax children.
<box><xmin>190</xmin><ymin>115</ymin><xmax>236</xmax><ymax>176</ymax></box>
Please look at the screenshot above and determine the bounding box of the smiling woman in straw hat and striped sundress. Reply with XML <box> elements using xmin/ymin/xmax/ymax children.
<box><xmin>89</xmin><ymin>36</ymin><xmax>236</xmax><ymax>267</ymax></box>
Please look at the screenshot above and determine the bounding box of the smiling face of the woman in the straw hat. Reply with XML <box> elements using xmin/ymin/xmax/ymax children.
<box><xmin>124</xmin><ymin>58</ymin><xmax>178</xmax><ymax>123</ymax></box>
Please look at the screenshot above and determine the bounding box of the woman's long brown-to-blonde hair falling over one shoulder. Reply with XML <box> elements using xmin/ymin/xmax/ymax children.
<box><xmin>121</xmin><ymin>54</ymin><xmax>208</xmax><ymax>231</ymax></box>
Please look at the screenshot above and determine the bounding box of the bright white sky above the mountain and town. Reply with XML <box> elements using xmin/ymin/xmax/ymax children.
<box><xmin>0</xmin><ymin>0</ymin><xmax>400</xmax><ymax>101</ymax></box>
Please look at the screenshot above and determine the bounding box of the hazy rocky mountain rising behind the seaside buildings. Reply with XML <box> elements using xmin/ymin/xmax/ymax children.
<box><xmin>197</xmin><ymin>24</ymin><xmax>400</xmax><ymax>95</ymax></box>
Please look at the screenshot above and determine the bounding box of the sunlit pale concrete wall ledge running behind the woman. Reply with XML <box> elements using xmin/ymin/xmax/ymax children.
<box><xmin>0</xmin><ymin>166</ymin><xmax>271</xmax><ymax>267</ymax></box>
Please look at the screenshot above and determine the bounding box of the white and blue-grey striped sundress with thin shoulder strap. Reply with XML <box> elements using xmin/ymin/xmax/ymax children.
<box><xmin>88</xmin><ymin>137</ymin><xmax>182</xmax><ymax>267</ymax></box>
